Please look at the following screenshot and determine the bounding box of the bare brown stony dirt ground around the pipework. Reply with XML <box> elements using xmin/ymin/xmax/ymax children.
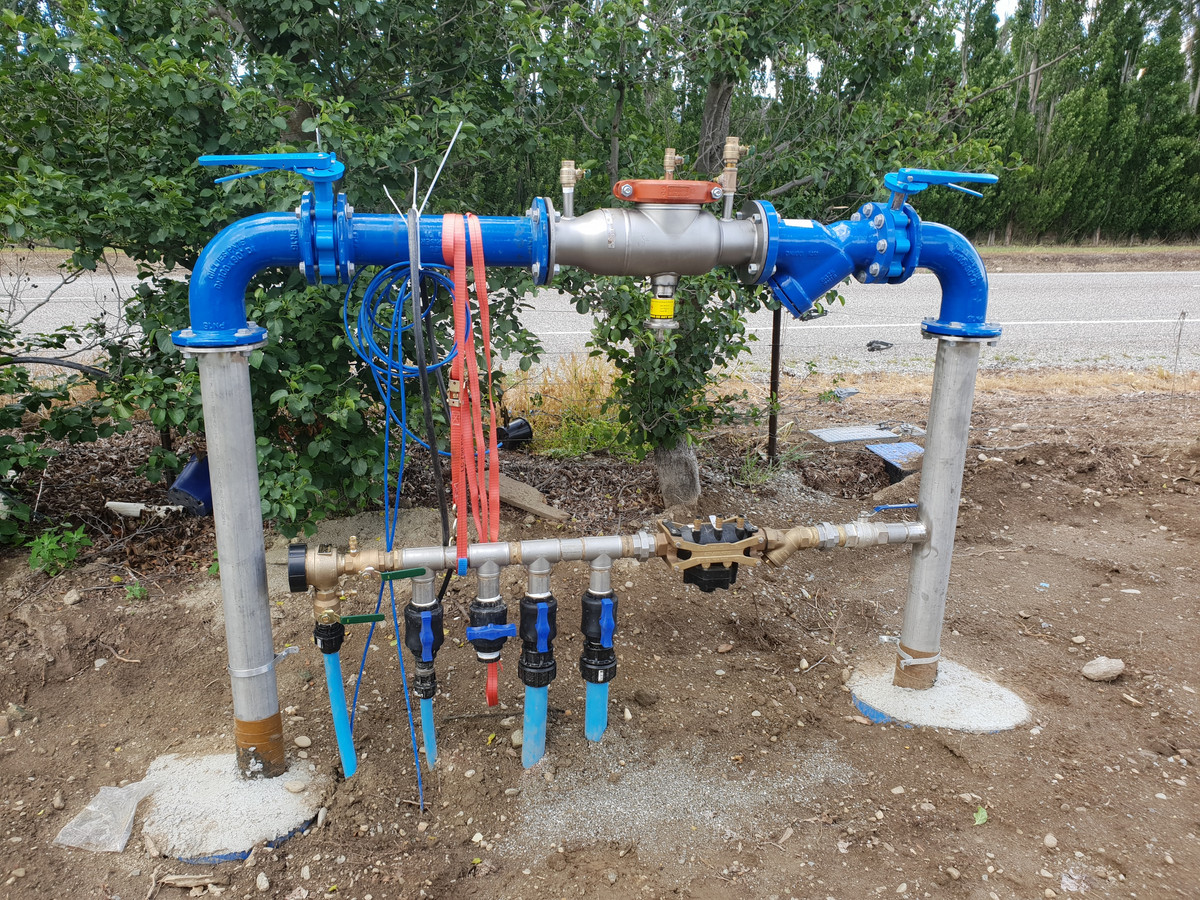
<box><xmin>0</xmin><ymin>362</ymin><xmax>1200</xmax><ymax>900</ymax></box>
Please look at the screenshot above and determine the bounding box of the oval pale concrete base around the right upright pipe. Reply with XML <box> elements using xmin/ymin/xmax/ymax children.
<box><xmin>848</xmin><ymin>659</ymin><xmax>1030</xmax><ymax>733</ymax></box>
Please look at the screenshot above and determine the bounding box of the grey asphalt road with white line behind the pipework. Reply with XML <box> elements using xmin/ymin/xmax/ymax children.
<box><xmin>11</xmin><ymin>266</ymin><xmax>1200</xmax><ymax>372</ymax></box>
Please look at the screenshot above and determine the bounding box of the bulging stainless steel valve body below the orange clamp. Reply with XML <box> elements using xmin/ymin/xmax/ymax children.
<box><xmin>550</xmin><ymin>203</ymin><xmax>767</xmax><ymax>275</ymax></box>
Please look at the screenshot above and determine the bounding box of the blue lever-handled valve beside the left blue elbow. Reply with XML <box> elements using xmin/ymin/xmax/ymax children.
<box><xmin>197</xmin><ymin>154</ymin><xmax>354</xmax><ymax>284</ymax></box>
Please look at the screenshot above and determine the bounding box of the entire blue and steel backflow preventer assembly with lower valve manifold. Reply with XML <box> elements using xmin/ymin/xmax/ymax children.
<box><xmin>173</xmin><ymin>138</ymin><xmax>1001</xmax><ymax>776</ymax></box>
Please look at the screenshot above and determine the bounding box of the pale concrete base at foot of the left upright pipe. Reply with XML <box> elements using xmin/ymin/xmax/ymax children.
<box><xmin>142</xmin><ymin>754</ymin><xmax>329</xmax><ymax>864</ymax></box>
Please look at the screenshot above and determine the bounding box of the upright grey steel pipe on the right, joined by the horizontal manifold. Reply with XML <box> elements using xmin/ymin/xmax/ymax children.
<box><xmin>893</xmin><ymin>338</ymin><xmax>980</xmax><ymax>689</ymax></box>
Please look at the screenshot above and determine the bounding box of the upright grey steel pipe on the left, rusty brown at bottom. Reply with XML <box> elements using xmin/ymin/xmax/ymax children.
<box><xmin>196</xmin><ymin>347</ymin><xmax>286</xmax><ymax>776</ymax></box>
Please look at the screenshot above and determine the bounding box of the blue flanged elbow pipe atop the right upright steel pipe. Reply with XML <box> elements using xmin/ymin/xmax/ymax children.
<box><xmin>917</xmin><ymin>222</ymin><xmax>1000</xmax><ymax>337</ymax></box>
